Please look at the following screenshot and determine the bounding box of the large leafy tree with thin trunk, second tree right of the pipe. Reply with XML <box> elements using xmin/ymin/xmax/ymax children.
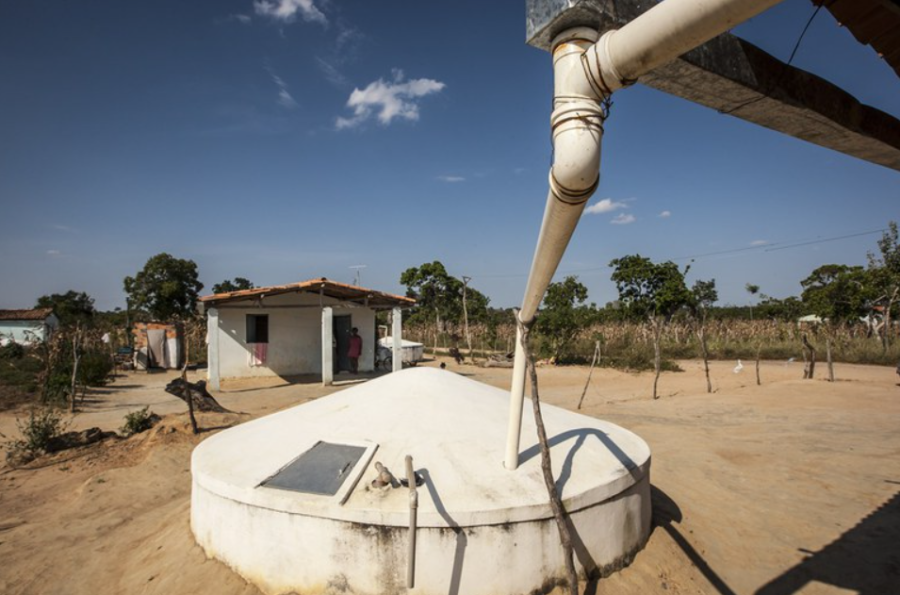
<box><xmin>609</xmin><ymin>254</ymin><xmax>691</xmax><ymax>399</ymax></box>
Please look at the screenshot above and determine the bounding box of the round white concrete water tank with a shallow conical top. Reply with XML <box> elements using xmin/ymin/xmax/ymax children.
<box><xmin>191</xmin><ymin>368</ymin><xmax>650</xmax><ymax>595</ymax></box>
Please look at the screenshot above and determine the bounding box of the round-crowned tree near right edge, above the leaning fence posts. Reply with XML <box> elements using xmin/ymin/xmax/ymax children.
<box><xmin>800</xmin><ymin>264</ymin><xmax>872</xmax><ymax>382</ymax></box>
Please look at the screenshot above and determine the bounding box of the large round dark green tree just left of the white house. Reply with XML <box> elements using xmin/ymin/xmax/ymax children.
<box><xmin>124</xmin><ymin>252</ymin><xmax>203</xmax><ymax>320</ymax></box>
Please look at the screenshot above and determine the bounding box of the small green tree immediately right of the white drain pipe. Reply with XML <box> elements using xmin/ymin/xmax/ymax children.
<box><xmin>535</xmin><ymin>277</ymin><xmax>590</xmax><ymax>362</ymax></box>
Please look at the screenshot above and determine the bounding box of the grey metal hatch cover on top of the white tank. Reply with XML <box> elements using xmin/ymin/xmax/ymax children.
<box><xmin>260</xmin><ymin>441</ymin><xmax>368</xmax><ymax>496</ymax></box>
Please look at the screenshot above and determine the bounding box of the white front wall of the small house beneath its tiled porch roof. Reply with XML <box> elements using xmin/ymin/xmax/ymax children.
<box><xmin>217</xmin><ymin>294</ymin><xmax>375</xmax><ymax>379</ymax></box>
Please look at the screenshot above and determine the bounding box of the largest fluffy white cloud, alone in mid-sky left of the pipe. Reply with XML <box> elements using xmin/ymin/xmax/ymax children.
<box><xmin>335</xmin><ymin>69</ymin><xmax>446</xmax><ymax>130</ymax></box>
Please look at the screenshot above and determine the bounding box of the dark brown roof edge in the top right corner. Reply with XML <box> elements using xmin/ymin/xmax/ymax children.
<box><xmin>812</xmin><ymin>0</ymin><xmax>900</xmax><ymax>76</ymax></box>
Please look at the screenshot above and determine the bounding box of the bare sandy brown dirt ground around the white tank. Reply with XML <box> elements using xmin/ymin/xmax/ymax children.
<box><xmin>0</xmin><ymin>361</ymin><xmax>900</xmax><ymax>595</ymax></box>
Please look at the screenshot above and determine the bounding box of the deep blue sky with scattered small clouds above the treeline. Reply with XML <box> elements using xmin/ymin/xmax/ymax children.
<box><xmin>0</xmin><ymin>0</ymin><xmax>900</xmax><ymax>309</ymax></box>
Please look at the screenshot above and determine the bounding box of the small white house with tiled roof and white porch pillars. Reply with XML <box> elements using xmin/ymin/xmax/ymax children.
<box><xmin>200</xmin><ymin>277</ymin><xmax>415</xmax><ymax>389</ymax></box>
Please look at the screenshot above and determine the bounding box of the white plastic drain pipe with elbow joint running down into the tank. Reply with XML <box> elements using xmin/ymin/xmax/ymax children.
<box><xmin>503</xmin><ymin>0</ymin><xmax>782</xmax><ymax>470</ymax></box>
